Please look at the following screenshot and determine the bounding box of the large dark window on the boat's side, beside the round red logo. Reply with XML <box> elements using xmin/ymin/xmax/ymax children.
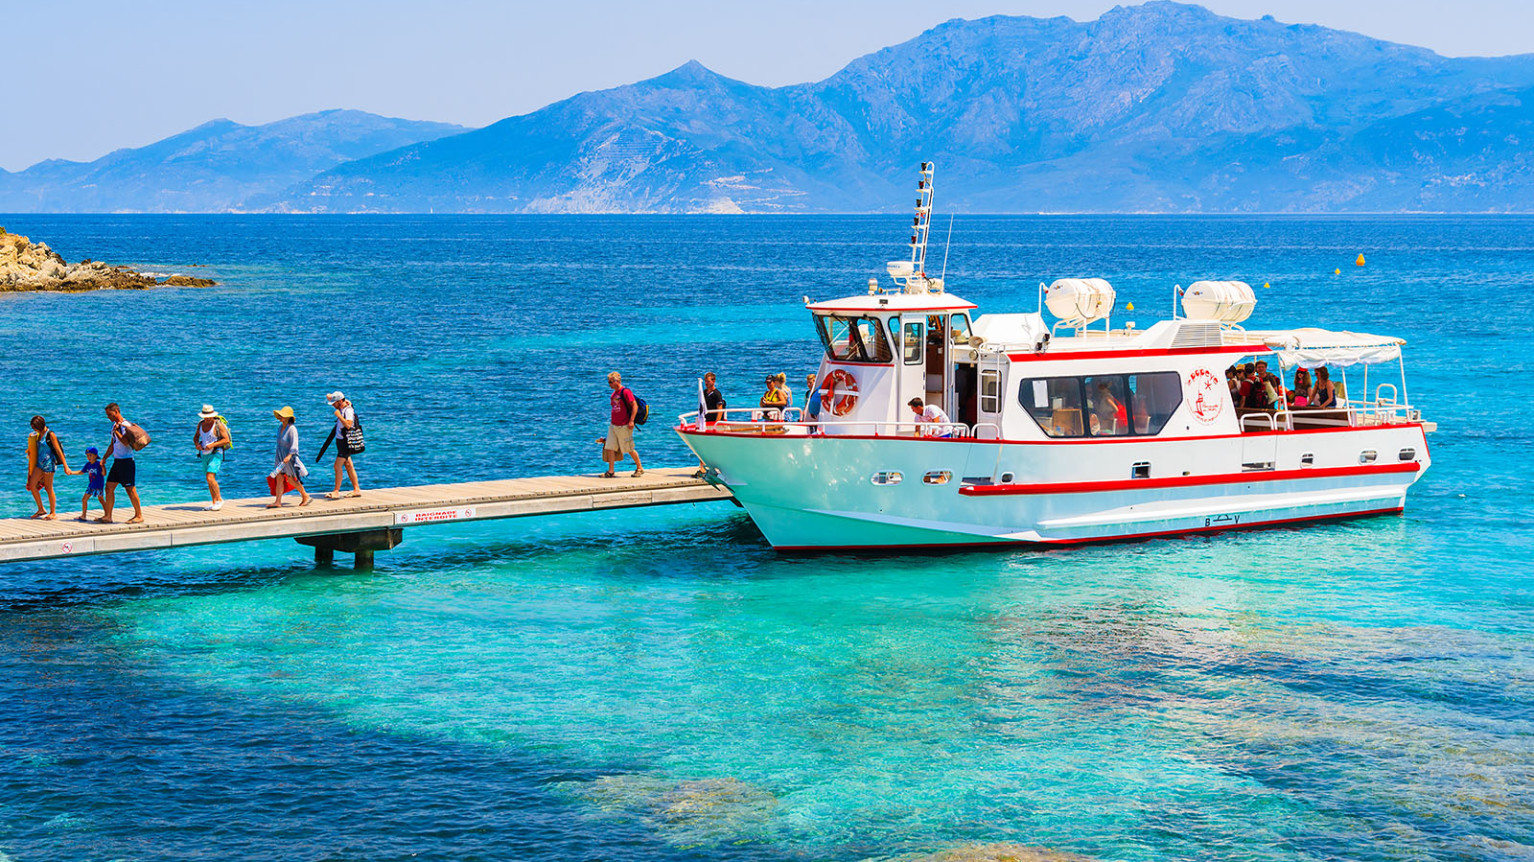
<box><xmin>1017</xmin><ymin>371</ymin><xmax>1183</xmax><ymax>437</ymax></box>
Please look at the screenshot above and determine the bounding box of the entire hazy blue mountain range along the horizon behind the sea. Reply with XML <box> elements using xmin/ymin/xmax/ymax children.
<box><xmin>0</xmin><ymin>0</ymin><xmax>1534</xmax><ymax>213</ymax></box>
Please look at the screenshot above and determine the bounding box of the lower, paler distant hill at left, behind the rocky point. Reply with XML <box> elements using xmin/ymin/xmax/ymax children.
<box><xmin>0</xmin><ymin>110</ymin><xmax>463</xmax><ymax>213</ymax></box>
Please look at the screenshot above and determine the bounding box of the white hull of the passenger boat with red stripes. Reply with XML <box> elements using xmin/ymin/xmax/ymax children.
<box><xmin>678</xmin><ymin>425</ymin><xmax>1428</xmax><ymax>551</ymax></box>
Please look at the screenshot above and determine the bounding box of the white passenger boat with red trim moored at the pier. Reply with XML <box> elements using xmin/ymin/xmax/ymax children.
<box><xmin>676</xmin><ymin>163</ymin><xmax>1433</xmax><ymax>549</ymax></box>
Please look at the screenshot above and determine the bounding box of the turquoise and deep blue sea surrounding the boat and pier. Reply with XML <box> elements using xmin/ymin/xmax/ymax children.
<box><xmin>0</xmin><ymin>216</ymin><xmax>1534</xmax><ymax>862</ymax></box>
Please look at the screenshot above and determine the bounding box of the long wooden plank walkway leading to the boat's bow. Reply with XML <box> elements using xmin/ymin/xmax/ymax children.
<box><xmin>0</xmin><ymin>468</ymin><xmax>730</xmax><ymax>561</ymax></box>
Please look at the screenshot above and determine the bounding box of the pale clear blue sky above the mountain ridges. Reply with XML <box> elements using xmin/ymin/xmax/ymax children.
<box><xmin>0</xmin><ymin>0</ymin><xmax>1534</xmax><ymax>170</ymax></box>
